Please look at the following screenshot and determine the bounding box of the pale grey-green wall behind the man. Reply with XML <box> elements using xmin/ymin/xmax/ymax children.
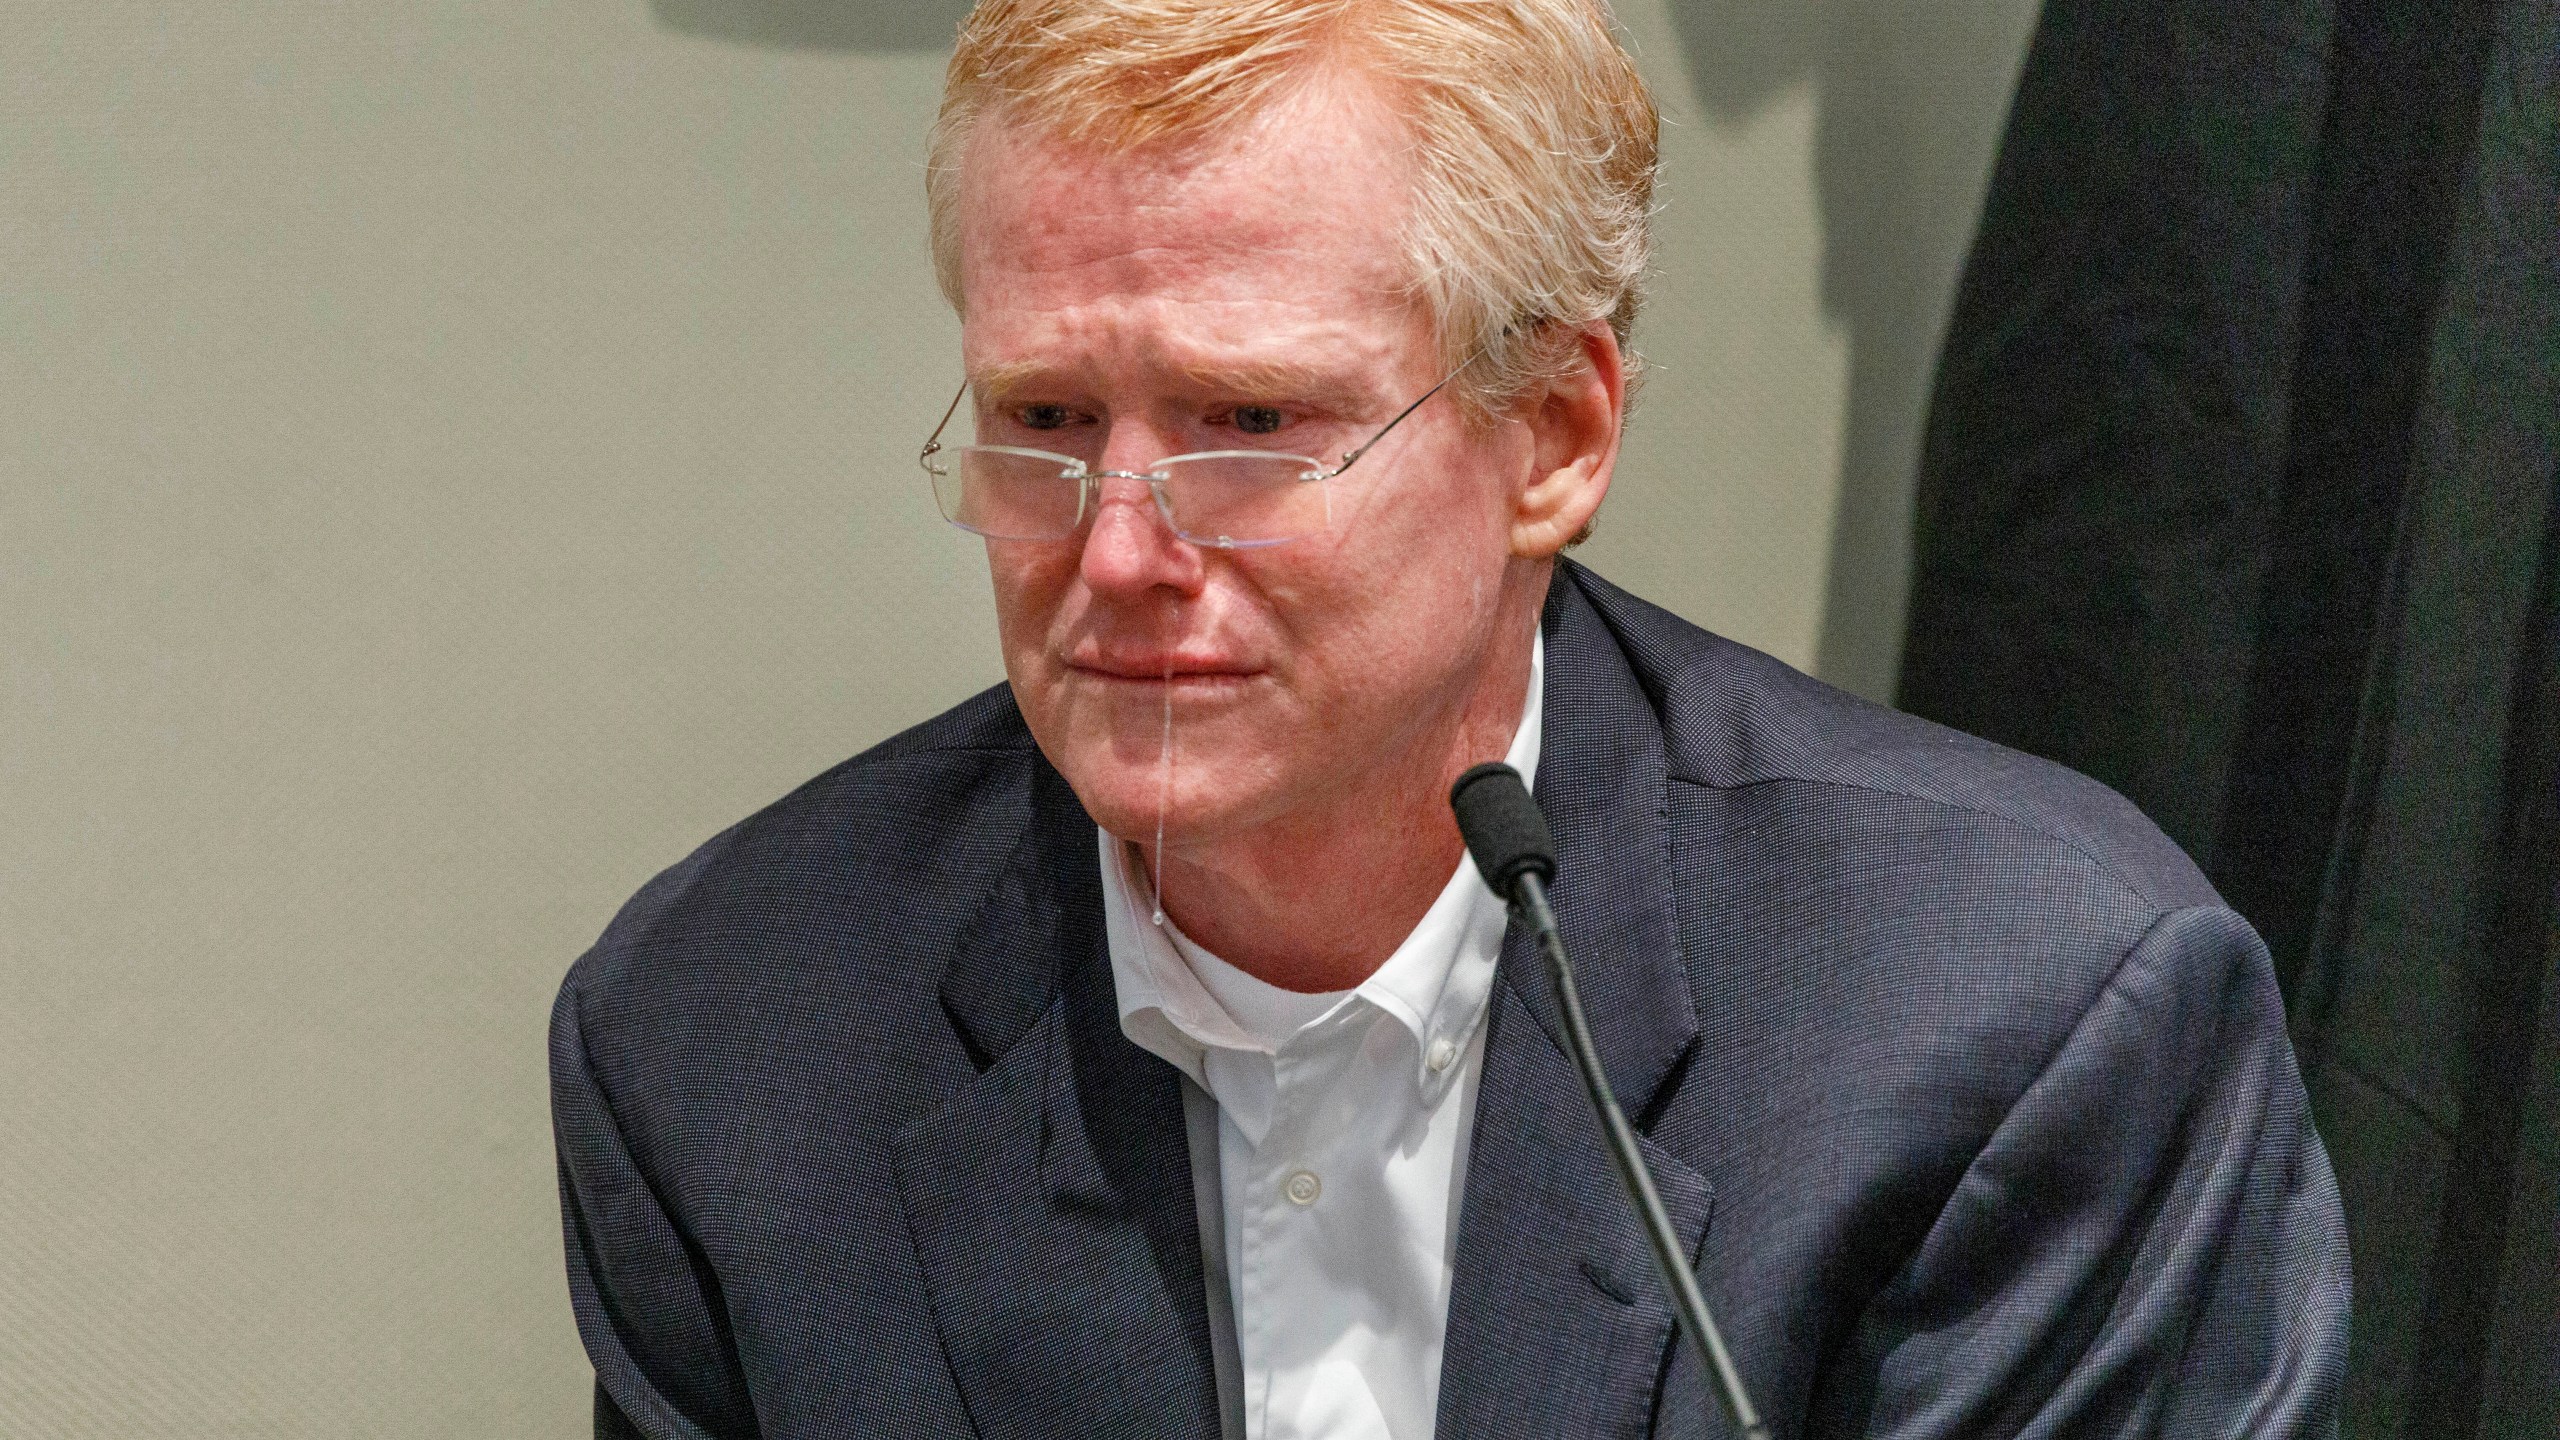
<box><xmin>0</xmin><ymin>0</ymin><xmax>2030</xmax><ymax>1440</ymax></box>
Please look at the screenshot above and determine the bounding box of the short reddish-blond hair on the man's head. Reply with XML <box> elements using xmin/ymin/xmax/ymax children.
<box><xmin>924</xmin><ymin>0</ymin><xmax>1659</xmax><ymax>415</ymax></box>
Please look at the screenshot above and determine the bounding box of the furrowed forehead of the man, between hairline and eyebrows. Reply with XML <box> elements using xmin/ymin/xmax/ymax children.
<box><xmin>957</xmin><ymin>72</ymin><xmax>1413</xmax><ymax>366</ymax></box>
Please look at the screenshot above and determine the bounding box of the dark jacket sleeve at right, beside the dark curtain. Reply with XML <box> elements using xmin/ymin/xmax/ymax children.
<box><xmin>1807</xmin><ymin>907</ymin><xmax>2348</xmax><ymax>1440</ymax></box>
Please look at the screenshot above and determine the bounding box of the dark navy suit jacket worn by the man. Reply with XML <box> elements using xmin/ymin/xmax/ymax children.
<box><xmin>550</xmin><ymin>564</ymin><xmax>2348</xmax><ymax>1440</ymax></box>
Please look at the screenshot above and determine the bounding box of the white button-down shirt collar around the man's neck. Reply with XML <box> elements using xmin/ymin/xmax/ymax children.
<box><xmin>1096</xmin><ymin>622</ymin><xmax>1546</xmax><ymax>1104</ymax></box>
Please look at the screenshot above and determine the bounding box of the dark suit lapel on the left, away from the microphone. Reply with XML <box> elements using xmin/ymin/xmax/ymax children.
<box><xmin>891</xmin><ymin>761</ymin><xmax>1219</xmax><ymax>1440</ymax></box>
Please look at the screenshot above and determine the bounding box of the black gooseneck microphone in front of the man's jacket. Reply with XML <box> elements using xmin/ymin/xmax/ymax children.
<box><xmin>1449</xmin><ymin>764</ymin><xmax>1769</xmax><ymax>1440</ymax></box>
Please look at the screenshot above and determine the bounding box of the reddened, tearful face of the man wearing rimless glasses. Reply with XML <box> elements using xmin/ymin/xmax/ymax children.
<box><xmin>960</xmin><ymin>77</ymin><xmax>1544</xmax><ymax>846</ymax></box>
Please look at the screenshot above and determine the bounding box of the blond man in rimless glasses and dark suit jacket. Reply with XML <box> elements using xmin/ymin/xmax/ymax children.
<box><xmin>553</xmin><ymin>0</ymin><xmax>2345</xmax><ymax>1437</ymax></box>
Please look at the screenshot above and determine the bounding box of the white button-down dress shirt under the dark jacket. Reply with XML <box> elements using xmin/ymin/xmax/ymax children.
<box><xmin>1101</xmin><ymin>638</ymin><xmax>1546</xmax><ymax>1440</ymax></box>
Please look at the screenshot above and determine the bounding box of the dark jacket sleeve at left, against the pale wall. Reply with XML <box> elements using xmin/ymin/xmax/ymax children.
<box><xmin>550</xmin><ymin>971</ymin><xmax>755</xmax><ymax>1440</ymax></box>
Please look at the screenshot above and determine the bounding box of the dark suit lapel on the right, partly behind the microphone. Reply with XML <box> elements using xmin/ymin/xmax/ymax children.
<box><xmin>1439</xmin><ymin>566</ymin><xmax>1713</xmax><ymax>1437</ymax></box>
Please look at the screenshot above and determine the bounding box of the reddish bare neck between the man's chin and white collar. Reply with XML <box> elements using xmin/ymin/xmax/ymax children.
<box><xmin>1139</xmin><ymin>584</ymin><xmax>1536</xmax><ymax>994</ymax></box>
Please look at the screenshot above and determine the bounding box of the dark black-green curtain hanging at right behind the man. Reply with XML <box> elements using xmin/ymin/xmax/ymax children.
<box><xmin>1900</xmin><ymin>0</ymin><xmax>2560</xmax><ymax>1440</ymax></box>
